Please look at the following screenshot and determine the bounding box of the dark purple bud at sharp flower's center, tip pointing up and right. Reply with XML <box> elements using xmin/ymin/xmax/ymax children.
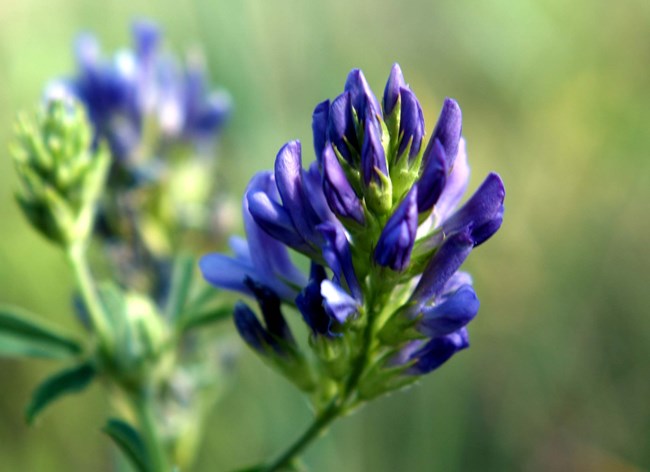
<box><xmin>374</xmin><ymin>187</ymin><xmax>418</xmax><ymax>272</ymax></box>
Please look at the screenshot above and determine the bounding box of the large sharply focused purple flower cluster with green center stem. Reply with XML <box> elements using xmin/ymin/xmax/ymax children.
<box><xmin>201</xmin><ymin>65</ymin><xmax>505</xmax><ymax>391</ymax></box>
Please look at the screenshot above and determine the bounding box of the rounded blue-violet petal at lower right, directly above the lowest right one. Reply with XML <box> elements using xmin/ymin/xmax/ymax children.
<box><xmin>417</xmin><ymin>285</ymin><xmax>480</xmax><ymax>338</ymax></box>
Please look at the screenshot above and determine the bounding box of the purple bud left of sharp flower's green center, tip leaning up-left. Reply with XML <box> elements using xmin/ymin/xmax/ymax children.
<box><xmin>322</xmin><ymin>143</ymin><xmax>365</xmax><ymax>225</ymax></box>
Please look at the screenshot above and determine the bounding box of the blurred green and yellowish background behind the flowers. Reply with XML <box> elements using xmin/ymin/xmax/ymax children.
<box><xmin>0</xmin><ymin>0</ymin><xmax>650</xmax><ymax>472</ymax></box>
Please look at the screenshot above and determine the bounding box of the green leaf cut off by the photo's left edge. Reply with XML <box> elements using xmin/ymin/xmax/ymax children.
<box><xmin>0</xmin><ymin>306</ymin><xmax>82</xmax><ymax>359</ymax></box>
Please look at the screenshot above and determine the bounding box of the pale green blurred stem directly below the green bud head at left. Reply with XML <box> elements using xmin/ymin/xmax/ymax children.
<box><xmin>66</xmin><ymin>243</ymin><xmax>113</xmax><ymax>350</ymax></box>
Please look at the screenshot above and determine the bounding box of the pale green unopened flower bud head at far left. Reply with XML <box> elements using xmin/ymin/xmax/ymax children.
<box><xmin>12</xmin><ymin>100</ymin><xmax>109</xmax><ymax>247</ymax></box>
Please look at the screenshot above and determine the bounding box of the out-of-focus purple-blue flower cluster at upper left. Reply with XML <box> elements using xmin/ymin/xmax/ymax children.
<box><xmin>46</xmin><ymin>21</ymin><xmax>231</xmax><ymax>162</ymax></box>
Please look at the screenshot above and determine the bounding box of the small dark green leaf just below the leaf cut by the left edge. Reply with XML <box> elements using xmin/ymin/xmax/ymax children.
<box><xmin>25</xmin><ymin>362</ymin><xmax>97</xmax><ymax>424</ymax></box>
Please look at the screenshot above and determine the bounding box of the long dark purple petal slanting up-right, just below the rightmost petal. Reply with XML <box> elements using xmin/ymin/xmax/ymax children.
<box><xmin>411</xmin><ymin>230</ymin><xmax>474</xmax><ymax>307</ymax></box>
